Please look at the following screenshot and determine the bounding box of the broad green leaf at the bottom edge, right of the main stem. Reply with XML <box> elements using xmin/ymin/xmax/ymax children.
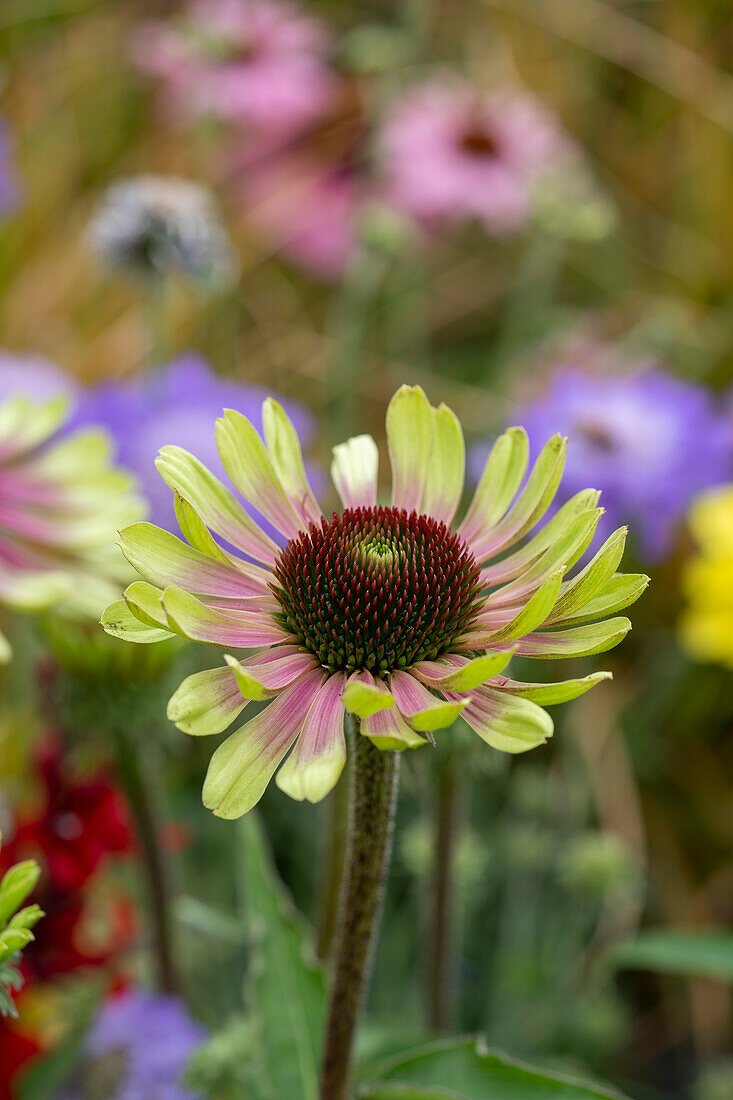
<box><xmin>359</xmin><ymin>1036</ymin><xmax>621</xmax><ymax>1100</ymax></box>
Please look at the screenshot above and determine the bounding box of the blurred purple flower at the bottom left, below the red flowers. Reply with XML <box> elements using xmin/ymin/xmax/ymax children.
<box><xmin>57</xmin><ymin>989</ymin><xmax>206</xmax><ymax>1100</ymax></box>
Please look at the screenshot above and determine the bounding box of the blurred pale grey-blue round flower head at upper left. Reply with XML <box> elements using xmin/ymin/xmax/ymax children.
<box><xmin>89</xmin><ymin>176</ymin><xmax>238</xmax><ymax>283</ymax></box>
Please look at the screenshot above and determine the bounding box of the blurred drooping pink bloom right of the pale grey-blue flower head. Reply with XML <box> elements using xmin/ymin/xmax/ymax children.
<box><xmin>241</xmin><ymin>153</ymin><xmax>360</xmax><ymax>279</ymax></box>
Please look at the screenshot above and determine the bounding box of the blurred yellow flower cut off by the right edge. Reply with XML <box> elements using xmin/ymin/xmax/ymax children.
<box><xmin>679</xmin><ymin>485</ymin><xmax>733</xmax><ymax>668</ymax></box>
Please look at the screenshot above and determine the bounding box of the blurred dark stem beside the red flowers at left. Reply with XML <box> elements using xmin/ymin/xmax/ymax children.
<box><xmin>116</xmin><ymin>730</ymin><xmax>179</xmax><ymax>993</ymax></box>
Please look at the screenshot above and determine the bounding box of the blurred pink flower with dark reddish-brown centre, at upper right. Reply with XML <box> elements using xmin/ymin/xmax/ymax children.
<box><xmin>378</xmin><ymin>80</ymin><xmax>575</xmax><ymax>235</ymax></box>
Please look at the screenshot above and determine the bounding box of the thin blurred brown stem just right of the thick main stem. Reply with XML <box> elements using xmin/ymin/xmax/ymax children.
<box><xmin>428</xmin><ymin>755</ymin><xmax>459</xmax><ymax>1032</ymax></box>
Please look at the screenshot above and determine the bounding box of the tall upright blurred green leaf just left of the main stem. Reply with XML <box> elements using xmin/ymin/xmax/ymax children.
<box><xmin>238</xmin><ymin>814</ymin><xmax>326</xmax><ymax>1100</ymax></box>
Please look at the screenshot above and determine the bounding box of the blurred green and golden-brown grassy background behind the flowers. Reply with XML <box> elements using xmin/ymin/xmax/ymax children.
<box><xmin>0</xmin><ymin>0</ymin><xmax>733</xmax><ymax>1100</ymax></box>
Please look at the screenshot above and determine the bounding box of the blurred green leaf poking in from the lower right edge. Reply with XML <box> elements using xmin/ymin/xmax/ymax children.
<box><xmin>611</xmin><ymin>930</ymin><xmax>733</xmax><ymax>982</ymax></box>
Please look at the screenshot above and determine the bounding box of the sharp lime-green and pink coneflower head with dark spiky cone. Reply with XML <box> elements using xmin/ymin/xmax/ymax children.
<box><xmin>103</xmin><ymin>386</ymin><xmax>647</xmax><ymax>817</ymax></box>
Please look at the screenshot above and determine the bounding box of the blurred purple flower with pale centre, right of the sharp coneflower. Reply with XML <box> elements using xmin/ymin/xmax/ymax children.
<box><xmin>470</xmin><ymin>367</ymin><xmax>733</xmax><ymax>561</ymax></box>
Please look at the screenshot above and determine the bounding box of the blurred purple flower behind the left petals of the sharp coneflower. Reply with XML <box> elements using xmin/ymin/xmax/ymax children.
<box><xmin>74</xmin><ymin>353</ymin><xmax>314</xmax><ymax>541</ymax></box>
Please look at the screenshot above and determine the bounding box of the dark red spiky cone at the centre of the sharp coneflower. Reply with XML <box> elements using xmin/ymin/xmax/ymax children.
<box><xmin>273</xmin><ymin>507</ymin><xmax>481</xmax><ymax>677</ymax></box>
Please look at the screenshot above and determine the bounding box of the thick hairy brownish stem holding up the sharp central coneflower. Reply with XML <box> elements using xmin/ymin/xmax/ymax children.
<box><xmin>320</xmin><ymin>716</ymin><xmax>400</xmax><ymax>1100</ymax></box>
